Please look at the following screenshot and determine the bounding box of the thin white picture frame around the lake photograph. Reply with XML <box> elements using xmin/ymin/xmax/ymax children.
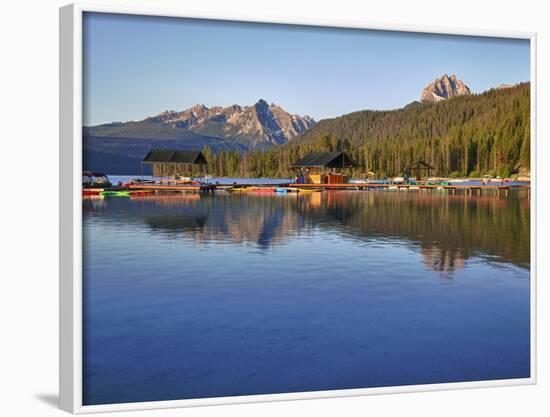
<box><xmin>59</xmin><ymin>3</ymin><xmax>537</xmax><ymax>414</ymax></box>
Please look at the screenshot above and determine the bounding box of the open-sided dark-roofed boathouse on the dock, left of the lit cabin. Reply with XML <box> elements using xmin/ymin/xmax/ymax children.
<box><xmin>141</xmin><ymin>149</ymin><xmax>206</xmax><ymax>178</ymax></box>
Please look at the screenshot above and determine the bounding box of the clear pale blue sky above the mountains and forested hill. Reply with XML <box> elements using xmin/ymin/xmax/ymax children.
<box><xmin>84</xmin><ymin>13</ymin><xmax>530</xmax><ymax>125</ymax></box>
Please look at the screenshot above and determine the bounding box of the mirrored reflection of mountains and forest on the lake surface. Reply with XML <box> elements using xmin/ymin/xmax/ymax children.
<box><xmin>84</xmin><ymin>191</ymin><xmax>530</xmax><ymax>273</ymax></box>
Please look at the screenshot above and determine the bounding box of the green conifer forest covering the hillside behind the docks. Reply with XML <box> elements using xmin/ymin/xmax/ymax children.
<box><xmin>198</xmin><ymin>83</ymin><xmax>530</xmax><ymax>178</ymax></box>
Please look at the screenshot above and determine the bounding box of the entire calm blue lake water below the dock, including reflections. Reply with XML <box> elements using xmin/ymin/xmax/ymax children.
<box><xmin>83</xmin><ymin>191</ymin><xmax>530</xmax><ymax>405</ymax></box>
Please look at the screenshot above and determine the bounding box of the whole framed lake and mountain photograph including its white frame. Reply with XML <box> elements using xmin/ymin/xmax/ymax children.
<box><xmin>60</xmin><ymin>5</ymin><xmax>537</xmax><ymax>413</ymax></box>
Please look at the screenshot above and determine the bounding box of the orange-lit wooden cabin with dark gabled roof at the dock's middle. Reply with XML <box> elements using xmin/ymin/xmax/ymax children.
<box><xmin>290</xmin><ymin>152</ymin><xmax>357</xmax><ymax>184</ymax></box>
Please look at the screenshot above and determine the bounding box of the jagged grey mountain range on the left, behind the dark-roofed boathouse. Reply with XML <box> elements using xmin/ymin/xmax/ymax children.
<box><xmin>83</xmin><ymin>99</ymin><xmax>316</xmax><ymax>173</ymax></box>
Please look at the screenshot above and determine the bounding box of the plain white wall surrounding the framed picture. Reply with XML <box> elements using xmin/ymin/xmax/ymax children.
<box><xmin>0</xmin><ymin>0</ymin><xmax>550</xmax><ymax>417</ymax></box>
